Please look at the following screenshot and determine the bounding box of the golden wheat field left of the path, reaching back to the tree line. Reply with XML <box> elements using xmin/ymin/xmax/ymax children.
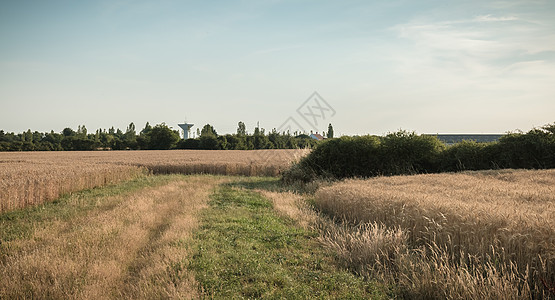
<box><xmin>0</xmin><ymin>150</ymin><xmax>308</xmax><ymax>212</ymax></box>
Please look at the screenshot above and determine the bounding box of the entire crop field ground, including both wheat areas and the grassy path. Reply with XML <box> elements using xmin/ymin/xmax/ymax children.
<box><xmin>0</xmin><ymin>150</ymin><xmax>555</xmax><ymax>299</ymax></box>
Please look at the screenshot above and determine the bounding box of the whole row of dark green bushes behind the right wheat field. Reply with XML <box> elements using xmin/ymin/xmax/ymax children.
<box><xmin>283</xmin><ymin>124</ymin><xmax>555</xmax><ymax>182</ymax></box>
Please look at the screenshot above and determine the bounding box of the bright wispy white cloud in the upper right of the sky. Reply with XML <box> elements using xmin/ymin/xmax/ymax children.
<box><xmin>391</xmin><ymin>15</ymin><xmax>555</xmax><ymax>65</ymax></box>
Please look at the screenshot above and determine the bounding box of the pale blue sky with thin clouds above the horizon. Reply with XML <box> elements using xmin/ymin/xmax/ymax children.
<box><xmin>0</xmin><ymin>0</ymin><xmax>555</xmax><ymax>135</ymax></box>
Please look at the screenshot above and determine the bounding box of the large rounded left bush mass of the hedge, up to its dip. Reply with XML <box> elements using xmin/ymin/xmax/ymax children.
<box><xmin>284</xmin><ymin>131</ymin><xmax>445</xmax><ymax>182</ymax></box>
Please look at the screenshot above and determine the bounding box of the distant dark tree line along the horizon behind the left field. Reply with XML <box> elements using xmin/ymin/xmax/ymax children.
<box><xmin>0</xmin><ymin>122</ymin><xmax>333</xmax><ymax>151</ymax></box>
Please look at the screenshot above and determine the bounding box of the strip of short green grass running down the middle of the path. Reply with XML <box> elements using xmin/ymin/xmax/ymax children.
<box><xmin>189</xmin><ymin>185</ymin><xmax>385</xmax><ymax>299</ymax></box>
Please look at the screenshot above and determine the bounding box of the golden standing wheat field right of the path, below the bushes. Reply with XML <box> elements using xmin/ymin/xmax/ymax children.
<box><xmin>316</xmin><ymin>170</ymin><xmax>555</xmax><ymax>299</ymax></box>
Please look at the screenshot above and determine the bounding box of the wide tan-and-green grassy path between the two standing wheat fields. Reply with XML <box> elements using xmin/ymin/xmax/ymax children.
<box><xmin>0</xmin><ymin>175</ymin><xmax>385</xmax><ymax>299</ymax></box>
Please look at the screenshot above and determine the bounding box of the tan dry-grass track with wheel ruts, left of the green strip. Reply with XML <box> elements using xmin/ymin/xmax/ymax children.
<box><xmin>0</xmin><ymin>176</ymin><xmax>224</xmax><ymax>299</ymax></box>
